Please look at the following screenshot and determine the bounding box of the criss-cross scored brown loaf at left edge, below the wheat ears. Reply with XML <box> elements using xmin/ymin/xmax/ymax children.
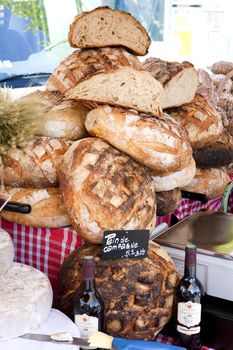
<box><xmin>2</xmin><ymin>137</ymin><xmax>71</xmax><ymax>188</ymax></box>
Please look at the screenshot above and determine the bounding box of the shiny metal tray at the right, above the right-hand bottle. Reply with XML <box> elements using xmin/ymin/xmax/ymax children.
<box><xmin>154</xmin><ymin>210</ymin><xmax>233</xmax><ymax>259</ymax></box>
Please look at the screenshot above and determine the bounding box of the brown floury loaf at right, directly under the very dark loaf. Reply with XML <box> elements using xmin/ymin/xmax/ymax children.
<box><xmin>182</xmin><ymin>168</ymin><xmax>231</xmax><ymax>199</ymax></box>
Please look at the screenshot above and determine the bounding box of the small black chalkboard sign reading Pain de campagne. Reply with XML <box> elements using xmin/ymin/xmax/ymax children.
<box><xmin>102</xmin><ymin>230</ymin><xmax>150</xmax><ymax>260</ymax></box>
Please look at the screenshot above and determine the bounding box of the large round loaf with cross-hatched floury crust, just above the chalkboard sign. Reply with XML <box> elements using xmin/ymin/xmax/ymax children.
<box><xmin>58</xmin><ymin>138</ymin><xmax>156</xmax><ymax>243</ymax></box>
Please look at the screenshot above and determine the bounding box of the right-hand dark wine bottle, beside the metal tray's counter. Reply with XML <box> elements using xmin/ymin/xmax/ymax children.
<box><xmin>175</xmin><ymin>244</ymin><xmax>204</xmax><ymax>350</ymax></box>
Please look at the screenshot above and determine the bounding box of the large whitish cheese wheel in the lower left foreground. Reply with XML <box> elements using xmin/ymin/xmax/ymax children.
<box><xmin>0</xmin><ymin>263</ymin><xmax>53</xmax><ymax>340</ymax></box>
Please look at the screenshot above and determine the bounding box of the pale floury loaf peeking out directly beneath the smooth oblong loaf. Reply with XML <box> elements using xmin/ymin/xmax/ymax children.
<box><xmin>150</xmin><ymin>157</ymin><xmax>196</xmax><ymax>192</ymax></box>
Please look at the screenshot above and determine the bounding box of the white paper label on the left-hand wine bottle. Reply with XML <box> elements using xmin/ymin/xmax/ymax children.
<box><xmin>74</xmin><ymin>314</ymin><xmax>98</xmax><ymax>349</ymax></box>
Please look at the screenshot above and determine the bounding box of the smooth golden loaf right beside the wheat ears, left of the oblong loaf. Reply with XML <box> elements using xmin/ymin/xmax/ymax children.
<box><xmin>37</xmin><ymin>100</ymin><xmax>90</xmax><ymax>140</ymax></box>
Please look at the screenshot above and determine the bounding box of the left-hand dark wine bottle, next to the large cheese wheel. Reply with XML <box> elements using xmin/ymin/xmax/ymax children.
<box><xmin>74</xmin><ymin>256</ymin><xmax>104</xmax><ymax>349</ymax></box>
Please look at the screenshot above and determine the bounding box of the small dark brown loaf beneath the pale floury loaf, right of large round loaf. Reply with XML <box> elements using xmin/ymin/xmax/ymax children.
<box><xmin>156</xmin><ymin>188</ymin><xmax>182</xmax><ymax>216</ymax></box>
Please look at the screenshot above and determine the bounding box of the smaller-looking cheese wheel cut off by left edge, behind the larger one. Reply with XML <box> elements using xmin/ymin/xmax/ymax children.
<box><xmin>0</xmin><ymin>228</ymin><xmax>14</xmax><ymax>275</ymax></box>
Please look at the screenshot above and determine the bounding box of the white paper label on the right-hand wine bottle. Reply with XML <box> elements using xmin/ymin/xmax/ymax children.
<box><xmin>177</xmin><ymin>301</ymin><xmax>201</xmax><ymax>335</ymax></box>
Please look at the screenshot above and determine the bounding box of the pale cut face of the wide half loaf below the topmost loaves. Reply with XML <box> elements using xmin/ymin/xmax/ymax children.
<box><xmin>66</xmin><ymin>67</ymin><xmax>164</xmax><ymax>116</ymax></box>
